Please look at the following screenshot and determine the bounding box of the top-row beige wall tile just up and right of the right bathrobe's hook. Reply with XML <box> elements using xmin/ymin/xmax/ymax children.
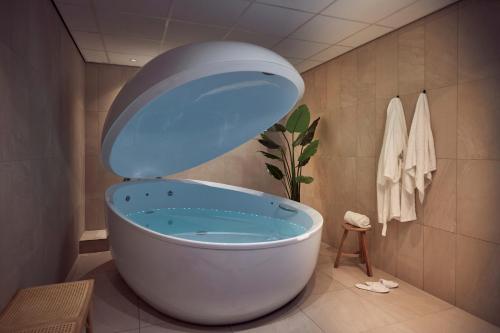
<box><xmin>425</xmin><ymin>6</ymin><xmax>458</xmax><ymax>89</ymax></box>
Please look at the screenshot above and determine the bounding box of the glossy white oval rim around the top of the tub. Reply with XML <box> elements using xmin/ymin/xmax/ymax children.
<box><xmin>105</xmin><ymin>179</ymin><xmax>323</xmax><ymax>250</ymax></box>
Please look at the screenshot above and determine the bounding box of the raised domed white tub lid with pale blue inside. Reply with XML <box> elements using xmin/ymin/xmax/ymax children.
<box><xmin>101</xmin><ymin>42</ymin><xmax>304</xmax><ymax>178</ymax></box>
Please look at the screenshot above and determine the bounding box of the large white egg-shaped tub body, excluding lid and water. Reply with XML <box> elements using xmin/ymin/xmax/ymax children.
<box><xmin>106</xmin><ymin>180</ymin><xmax>323</xmax><ymax>325</ymax></box>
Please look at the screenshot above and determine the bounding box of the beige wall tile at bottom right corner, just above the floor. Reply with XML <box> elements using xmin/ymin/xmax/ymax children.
<box><xmin>456</xmin><ymin>235</ymin><xmax>500</xmax><ymax>325</ymax></box>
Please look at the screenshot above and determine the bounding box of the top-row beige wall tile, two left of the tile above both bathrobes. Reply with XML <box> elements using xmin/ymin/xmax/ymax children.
<box><xmin>357</xmin><ymin>42</ymin><xmax>377</xmax><ymax>103</ymax></box>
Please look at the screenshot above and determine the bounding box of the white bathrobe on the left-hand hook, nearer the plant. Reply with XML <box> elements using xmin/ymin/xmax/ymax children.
<box><xmin>377</xmin><ymin>97</ymin><xmax>408</xmax><ymax>236</ymax></box>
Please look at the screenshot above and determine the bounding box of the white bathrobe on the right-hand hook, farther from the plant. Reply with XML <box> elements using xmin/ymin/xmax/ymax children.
<box><xmin>401</xmin><ymin>93</ymin><xmax>436</xmax><ymax>222</ymax></box>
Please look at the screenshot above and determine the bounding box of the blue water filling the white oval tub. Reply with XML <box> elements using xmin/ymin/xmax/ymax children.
<box><xmin>127</xmin><ymin>208</ymin><xmax>307</xmax><ymax>243</ymax></box>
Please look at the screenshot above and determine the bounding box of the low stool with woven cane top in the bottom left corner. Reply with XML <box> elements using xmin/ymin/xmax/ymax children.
<box><xmin>0</xmin><ymin>280</ymin><xmax>94</xmax><ymax>333</ymax></box>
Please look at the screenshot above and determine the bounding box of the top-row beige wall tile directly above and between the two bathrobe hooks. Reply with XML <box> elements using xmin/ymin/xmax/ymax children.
<box><xmin>398</xmin><ymin>24</ymin><xmax>425</xmax><ymax>95</ymax></box>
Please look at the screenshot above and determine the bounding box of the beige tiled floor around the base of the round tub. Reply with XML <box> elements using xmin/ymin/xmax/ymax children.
<box><xmin>70</xmin><ymin>245</ymin><xmax>500</xmax><ymax>333</ymax></box>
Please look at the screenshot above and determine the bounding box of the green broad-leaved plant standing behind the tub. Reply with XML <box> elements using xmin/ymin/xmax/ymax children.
<box><xmin>258</xmin><ymin>104</ymin><xmax>320</xmax><ymax>202</ymax></box>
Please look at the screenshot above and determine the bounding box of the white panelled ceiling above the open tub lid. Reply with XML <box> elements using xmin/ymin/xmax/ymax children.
<box><xmin>55</xmin><ymin>0</ymin><xmax>456</xmax><ymax>72</ymax></box>
